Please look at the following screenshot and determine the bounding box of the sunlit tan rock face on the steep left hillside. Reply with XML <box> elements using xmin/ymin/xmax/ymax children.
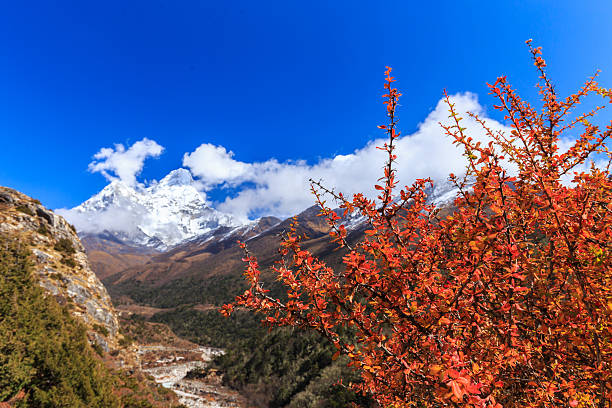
<box><xmin>0</xmin><ymin>187</ymin><xmax>119</xmax><ymax>352</ymax></box>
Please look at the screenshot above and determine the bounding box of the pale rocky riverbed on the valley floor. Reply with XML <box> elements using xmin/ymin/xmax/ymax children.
<box><xmin>137</xmin><ymin>345</ymin><xmax>246</xmax><ymax>408</ymax></box>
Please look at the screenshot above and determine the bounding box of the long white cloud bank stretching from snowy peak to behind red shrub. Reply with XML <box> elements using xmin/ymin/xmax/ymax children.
<box><xmin>183</xmin><ymin>93</ymin><xmax>506</xmax><ymax>219</ymax></box>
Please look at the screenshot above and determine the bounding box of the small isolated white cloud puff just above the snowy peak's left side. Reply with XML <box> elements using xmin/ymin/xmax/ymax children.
<box><xmin>88</xmin><ymin>138</ymin><xmax>164</xmax><ymax>186</ymax></box>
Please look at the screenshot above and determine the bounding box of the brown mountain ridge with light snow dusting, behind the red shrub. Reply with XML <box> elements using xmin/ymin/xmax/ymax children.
<box><xmin>84</xmin><ymin>179</ymin><xmax>457</xmax><ymax>307</ymax></box>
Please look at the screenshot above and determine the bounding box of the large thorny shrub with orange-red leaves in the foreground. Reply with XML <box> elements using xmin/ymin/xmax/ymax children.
<box><xmin>223</xmin><ymin>41</ymin><xmax>612</xmax><ymax>407</ymax></box>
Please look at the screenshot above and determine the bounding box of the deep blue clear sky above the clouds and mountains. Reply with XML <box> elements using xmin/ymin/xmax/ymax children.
<box><xmin>0</xmin><ymin>0</ymin><xmax>612</xmax><ymax>215</ymax></box>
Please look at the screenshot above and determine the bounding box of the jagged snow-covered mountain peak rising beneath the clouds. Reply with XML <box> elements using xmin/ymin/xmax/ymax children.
<box><xmin>60</xmin><ymin>169</ymin><xmax>244</xmax><ymax>250</ymax></box>
